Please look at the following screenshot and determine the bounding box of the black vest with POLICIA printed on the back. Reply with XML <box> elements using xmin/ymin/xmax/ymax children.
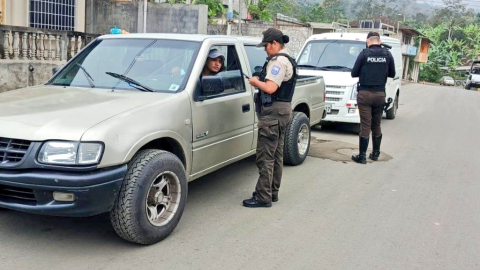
<box><xmin>359</xmin><ymin>48</ymin><xmax>389</xmax><ymax>89</ymax></box>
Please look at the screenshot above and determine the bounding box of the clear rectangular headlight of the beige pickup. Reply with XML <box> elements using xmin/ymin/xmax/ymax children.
<box><xmin>38</xmin><ymin>141</ymin><xmax>103</xmax><ymax>165</ymax></box>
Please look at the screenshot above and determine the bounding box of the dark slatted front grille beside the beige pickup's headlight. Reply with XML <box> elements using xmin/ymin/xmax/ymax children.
<box><xmin>0</xmin><ymin>137</ymin><xmax>32</xmax><ymax>166</ymax></box>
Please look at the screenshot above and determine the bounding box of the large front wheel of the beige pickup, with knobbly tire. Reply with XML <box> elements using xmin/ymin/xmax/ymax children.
<box><xmin>110</xmin><ymin>150</ymin><xmax>188</xmax><ymax>245</ymax></box>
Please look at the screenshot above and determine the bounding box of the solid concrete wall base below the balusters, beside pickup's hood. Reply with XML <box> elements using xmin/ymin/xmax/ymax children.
<box><xmin>0</xmin><ymin>60</ymin><xmax>66</xmax><ymax>93</ymax></box>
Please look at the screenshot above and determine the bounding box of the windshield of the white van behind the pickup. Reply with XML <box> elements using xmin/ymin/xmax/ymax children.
<box><xmin>297</xmin><ymin>40</ymin><xmax>366</xmax><ymax>71</ymax></box>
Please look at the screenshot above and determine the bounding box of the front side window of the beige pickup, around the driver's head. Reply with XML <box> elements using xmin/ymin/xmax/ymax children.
<box><xmin>197</xmin><ymin>45</ymin><xmax>246</xmax><ymax>98</ymax></box>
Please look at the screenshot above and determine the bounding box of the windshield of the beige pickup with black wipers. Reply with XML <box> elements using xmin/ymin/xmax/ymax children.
<box><xmin>48</xmin><ymin>38</ymin><xmax>200</xmax><ymax>93</ymax></box>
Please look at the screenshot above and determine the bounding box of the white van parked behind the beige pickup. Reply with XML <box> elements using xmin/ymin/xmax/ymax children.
<box><xmin>297</xmin><ymin>33</ymin><xmax>403</xmax><ymax>124</ymax></box>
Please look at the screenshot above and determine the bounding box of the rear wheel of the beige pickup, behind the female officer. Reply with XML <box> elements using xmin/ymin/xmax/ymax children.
<box><xmin>283</xmin><ymin>112</ymin><xmax>311</xmax><ymax>166</ymax></box>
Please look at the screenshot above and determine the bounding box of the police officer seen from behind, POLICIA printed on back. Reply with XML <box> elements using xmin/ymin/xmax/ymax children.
<box><xmin>352</xmin><ymin>32</ymin><xmax>395</xmax><ymax>164</ymax></box>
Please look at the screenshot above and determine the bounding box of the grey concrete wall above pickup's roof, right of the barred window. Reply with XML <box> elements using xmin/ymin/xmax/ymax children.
<box><xmin>86</xmin><ymin>0</ymin><xmax>208</xmax><ymax>34</ymax></box>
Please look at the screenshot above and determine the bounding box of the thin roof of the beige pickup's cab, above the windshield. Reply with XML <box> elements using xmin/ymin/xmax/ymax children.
<box><xmin>99</xmin><ymin>33</ymin><xmax>261</xmax><ymax>43</ymax></box>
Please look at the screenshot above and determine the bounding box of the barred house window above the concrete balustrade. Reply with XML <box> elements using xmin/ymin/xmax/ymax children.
<box><xmin>30</xmin><ymin>0</ymin><xmax>76</xmax><ymax>31</ymax></box>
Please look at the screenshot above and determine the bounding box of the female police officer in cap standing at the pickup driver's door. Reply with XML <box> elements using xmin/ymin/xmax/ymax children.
<box><xmin>243</xmin><ymin>28</ymin><xmax>297</xmax><ymax>207</ymax></box>
